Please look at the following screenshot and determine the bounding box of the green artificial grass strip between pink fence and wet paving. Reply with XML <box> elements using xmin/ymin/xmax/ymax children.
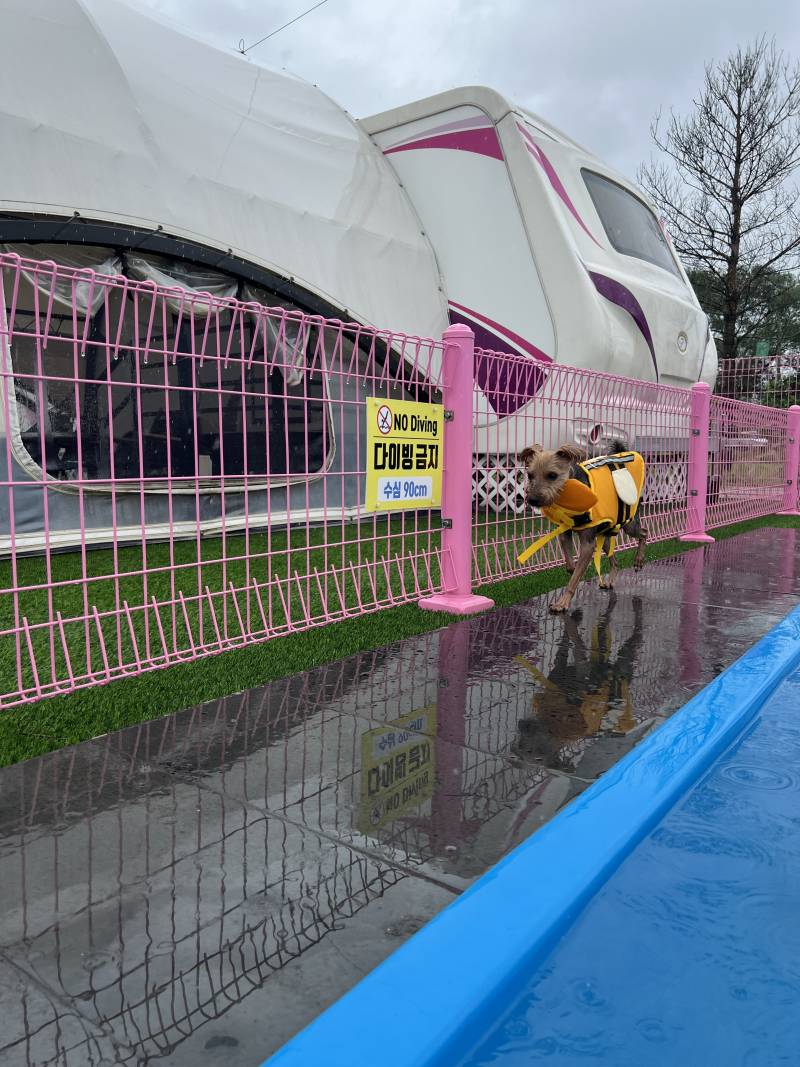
<box><xmin>0</xmin><ymin>507</ymin><xmax>800</xmax><ymax>766</ymax></box>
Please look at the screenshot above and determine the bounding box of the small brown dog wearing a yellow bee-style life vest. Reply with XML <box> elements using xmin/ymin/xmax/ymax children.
<box><xmin>519</xmin><ymin>441</ymin><xmax>647</xmax><ymax>612</ymax></box>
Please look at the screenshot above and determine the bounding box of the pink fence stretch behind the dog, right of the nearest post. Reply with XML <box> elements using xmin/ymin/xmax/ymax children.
<box><xmin>473</xmin><ymin>349</ymin><xmax>800</xmax><ymax>582</ymax></box>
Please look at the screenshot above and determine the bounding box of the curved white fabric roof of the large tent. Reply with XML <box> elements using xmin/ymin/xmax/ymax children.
<box><xmin>0</xmin><ymin>0</ymin><xmax>447</xmax><ymax>336</ymax></box>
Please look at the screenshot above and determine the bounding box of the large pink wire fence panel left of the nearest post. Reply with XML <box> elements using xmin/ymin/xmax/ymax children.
<box><xmin>0</xmin><ymin>254</ymin><xmax>442</xmax><ymax>707</ymax></box>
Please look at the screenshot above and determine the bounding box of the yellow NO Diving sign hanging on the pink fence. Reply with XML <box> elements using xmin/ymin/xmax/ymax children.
<box><xmin>366</xmin><ymin>397</ymin><xmax>445</xmax><ymax>511</ymax></box>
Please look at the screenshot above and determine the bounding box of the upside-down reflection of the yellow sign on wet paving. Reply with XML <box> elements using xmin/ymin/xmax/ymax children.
<box><xmin>358</xmin><ymin>705</ymin><xmax>436</xmax><ymax>834</ymax></box>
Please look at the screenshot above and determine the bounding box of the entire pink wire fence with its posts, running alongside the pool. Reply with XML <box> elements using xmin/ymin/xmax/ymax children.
<box><xmin>0</xmin><ymin>254</ymin><xmax>800</xmax><ymax>707</ymax></box>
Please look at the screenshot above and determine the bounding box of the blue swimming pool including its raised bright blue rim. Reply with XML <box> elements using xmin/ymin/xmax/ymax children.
<box><xmin>270</xmin><ymin>608</ymin><xmax>800</xmax><ymax>1067</ymax></box>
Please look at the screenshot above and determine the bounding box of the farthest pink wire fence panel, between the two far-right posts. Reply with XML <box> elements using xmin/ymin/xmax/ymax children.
<box><xmin>706</xmin><ymin>396</ymin><xmax>789</xmax><ymax>527</ymax></box>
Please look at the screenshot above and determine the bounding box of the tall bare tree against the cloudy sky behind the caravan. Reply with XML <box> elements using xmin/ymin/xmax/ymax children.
<box><xmin>639</xmin><ymin>38</ymin><xmax>800</xmax><ymax>359</ymax></box>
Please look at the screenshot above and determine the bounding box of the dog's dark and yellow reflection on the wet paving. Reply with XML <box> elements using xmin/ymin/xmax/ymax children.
<box><xmin>511</xmin><ymin>594</ymin><xmax>642</xmax><ymax>770</ymax></box>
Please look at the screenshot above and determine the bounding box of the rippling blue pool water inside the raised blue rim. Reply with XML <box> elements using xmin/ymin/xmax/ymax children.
<box><xmin>464</xmin><ymin>670</ymin><xmax>800</xmax><ymax>1067</ymax></box>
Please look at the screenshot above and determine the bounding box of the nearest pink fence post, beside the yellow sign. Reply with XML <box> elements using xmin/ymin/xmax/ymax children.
<box><xmin>419</xmin><ymin>324</ymin><xmax>494</xmax><ymax>615</ymax></box>
